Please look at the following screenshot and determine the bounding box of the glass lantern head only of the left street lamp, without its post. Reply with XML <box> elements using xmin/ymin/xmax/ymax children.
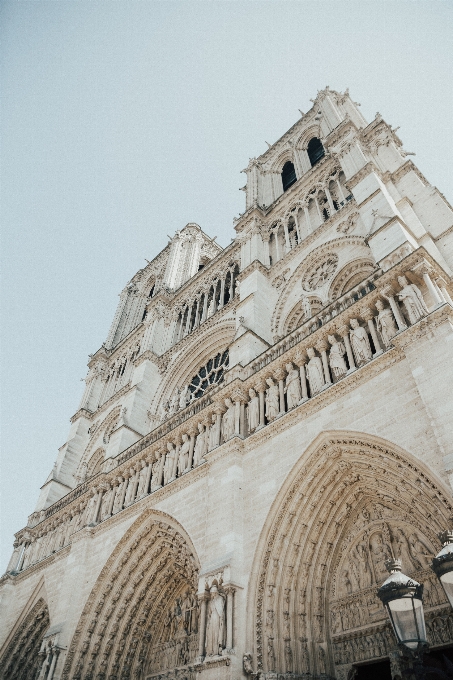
<box><xmin>377</xmin><ymin>559</ymin><xmax>428</xmax><ymax>652</ymax></box>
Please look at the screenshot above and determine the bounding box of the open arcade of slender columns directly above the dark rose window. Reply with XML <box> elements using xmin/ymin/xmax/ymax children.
<box><xmin>173</xmin><ymin>263</ymin><xmax>239</xmax><ymax>344</ymax></box>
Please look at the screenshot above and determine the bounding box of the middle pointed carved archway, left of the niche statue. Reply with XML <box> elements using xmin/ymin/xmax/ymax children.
<box><xmin>62</xmin><ymin>510</ymin><xmax>199</xmax><ymax>680</ymax></box>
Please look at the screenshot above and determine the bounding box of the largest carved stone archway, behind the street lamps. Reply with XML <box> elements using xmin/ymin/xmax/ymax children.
<box><xmin>249</xmin><ymin>432</ymin><xmax>453</xmax><ymax>680</ymax></box>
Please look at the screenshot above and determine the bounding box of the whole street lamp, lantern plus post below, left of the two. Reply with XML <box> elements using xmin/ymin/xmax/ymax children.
<box><xmin>377</xmin><ymin>559</ymin><xmax>428</xmax><ymax>680</ymax></box>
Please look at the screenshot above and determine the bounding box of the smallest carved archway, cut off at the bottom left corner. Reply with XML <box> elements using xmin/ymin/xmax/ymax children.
<box><xmin>0</xmin><ymin>598</ymin><xmax>50</xmax><ymax>680</ymax></box>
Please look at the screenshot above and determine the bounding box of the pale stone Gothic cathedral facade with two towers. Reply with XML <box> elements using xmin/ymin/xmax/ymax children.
<box><xmin>0</xmin><ymin>88</ymin><xmax>453</xmax><ymax>680</ymax></box>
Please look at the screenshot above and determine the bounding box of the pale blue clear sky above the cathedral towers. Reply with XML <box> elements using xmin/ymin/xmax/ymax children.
<box><xmin>0</xmin><ymin>0</ymin><xmax>453</xmax><ymax>572</ymax></box>
